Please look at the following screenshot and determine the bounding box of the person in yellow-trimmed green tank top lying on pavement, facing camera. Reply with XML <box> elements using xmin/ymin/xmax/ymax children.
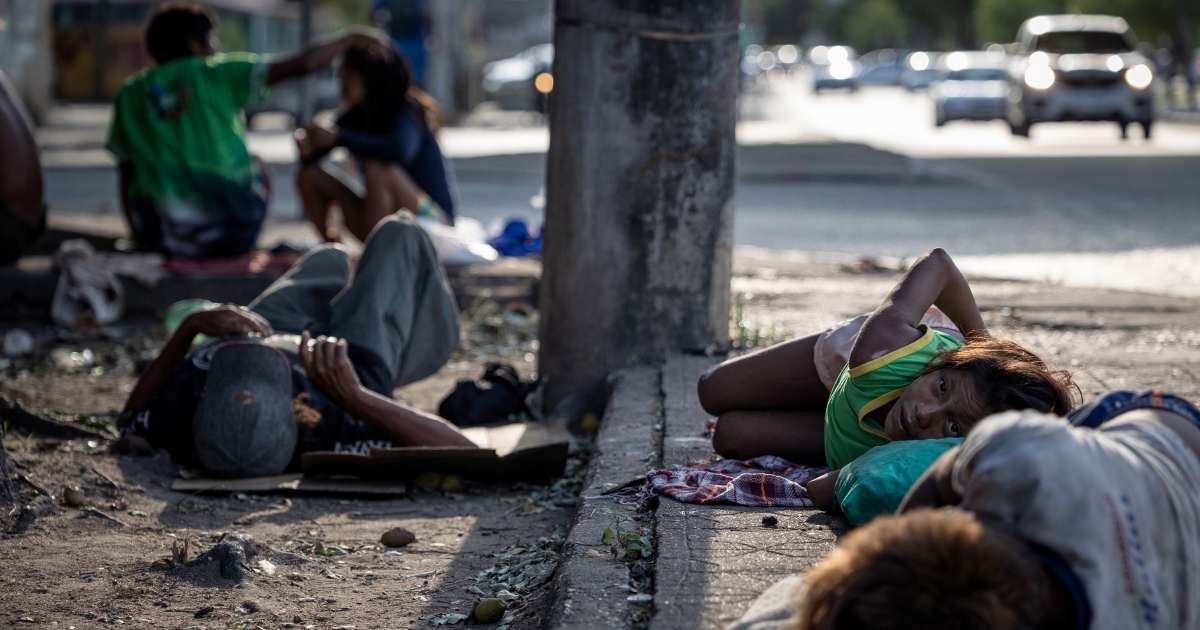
<box><xmin>698</xmin><ymin>248</ymin><xmax>1072</xmax><ymax>496</ymax></box>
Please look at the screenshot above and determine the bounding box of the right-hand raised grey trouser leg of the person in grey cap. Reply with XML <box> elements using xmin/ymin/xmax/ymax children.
<box><xmin>328</xmin><ymin>212</ymin><xmax>458</xmax><ymax>386</ymax></box>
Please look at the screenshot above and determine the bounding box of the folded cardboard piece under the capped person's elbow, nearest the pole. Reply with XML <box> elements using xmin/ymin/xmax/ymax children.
<box><xmin>300</xmin><ymin>422</ymin><xmax>570</xmax><ymax>481</ymax></box>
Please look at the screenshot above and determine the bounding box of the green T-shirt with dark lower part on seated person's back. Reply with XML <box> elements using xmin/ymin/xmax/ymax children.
<box><xmin>106</xmin><ymin>54</ymin><xmax>269</xmax><ymax>256</ymax></box>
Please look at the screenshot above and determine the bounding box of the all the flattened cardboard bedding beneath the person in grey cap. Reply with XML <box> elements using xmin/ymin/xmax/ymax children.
<box><xmin>170</xmin><ymin>422</ymin><xmax>571</xmax><ymax>496</ymax></box>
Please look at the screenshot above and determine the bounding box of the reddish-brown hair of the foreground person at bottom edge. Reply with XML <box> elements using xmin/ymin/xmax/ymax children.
<box><xmin>796</xmin><ymin>510</ymin><xmax>1045</xmax><ymax>630</ymax></box>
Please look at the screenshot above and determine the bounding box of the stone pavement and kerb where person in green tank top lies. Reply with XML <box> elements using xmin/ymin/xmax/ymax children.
<box><xmin>548</xmin><ymin>248</ymin><xmax>1200</xmax><ymax>630</ymax></box>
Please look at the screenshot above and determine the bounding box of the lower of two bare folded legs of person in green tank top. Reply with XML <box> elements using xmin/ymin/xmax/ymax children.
<box><xmin>713</xmin><ymin>409</ymin><xmax>826</xmax><ymax>466</ymax></box>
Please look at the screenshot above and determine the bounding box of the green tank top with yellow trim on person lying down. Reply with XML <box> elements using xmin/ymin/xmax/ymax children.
<box><xmin>824</xmin><ymin>324</ymin><xmax>962</xmax><ymax>468</ymax></box>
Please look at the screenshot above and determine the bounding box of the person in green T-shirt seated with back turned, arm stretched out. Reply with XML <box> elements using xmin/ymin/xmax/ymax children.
<box><xmin>106</xmin><ymin>2</ymin><xmax>392</xmax><ymax>258</ymax></box>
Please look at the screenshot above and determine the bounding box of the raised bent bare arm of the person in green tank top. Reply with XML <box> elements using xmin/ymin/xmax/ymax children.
<box><xmin>850</xmin><ymin>248</ymin><xmax>988</xmax><ymax>367</ymax></box>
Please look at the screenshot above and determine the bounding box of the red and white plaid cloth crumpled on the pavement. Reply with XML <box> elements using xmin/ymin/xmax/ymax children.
<box><xmin>616</xmin><ymin>455</ymin><xmax>829</xmax><ymax>508</ymax></box>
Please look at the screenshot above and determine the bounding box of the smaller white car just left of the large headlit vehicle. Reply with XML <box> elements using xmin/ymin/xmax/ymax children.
<box><xmin>929</xmin><ymin>50</ymin><xmax>1010</xmax><ymax>127</ymax></box>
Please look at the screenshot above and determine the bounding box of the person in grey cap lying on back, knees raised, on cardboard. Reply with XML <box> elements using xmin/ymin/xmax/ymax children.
<box><xmin>118</xmin><ymin>215</ymin><xmax>474</xmax><ymax>476</ymax></box>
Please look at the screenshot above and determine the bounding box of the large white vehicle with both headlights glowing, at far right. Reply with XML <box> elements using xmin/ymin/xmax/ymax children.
<box><xmin>1007</xmin><ymin>16</ymin><xmax>1154</xmax><ymax>138</ymax></box>
